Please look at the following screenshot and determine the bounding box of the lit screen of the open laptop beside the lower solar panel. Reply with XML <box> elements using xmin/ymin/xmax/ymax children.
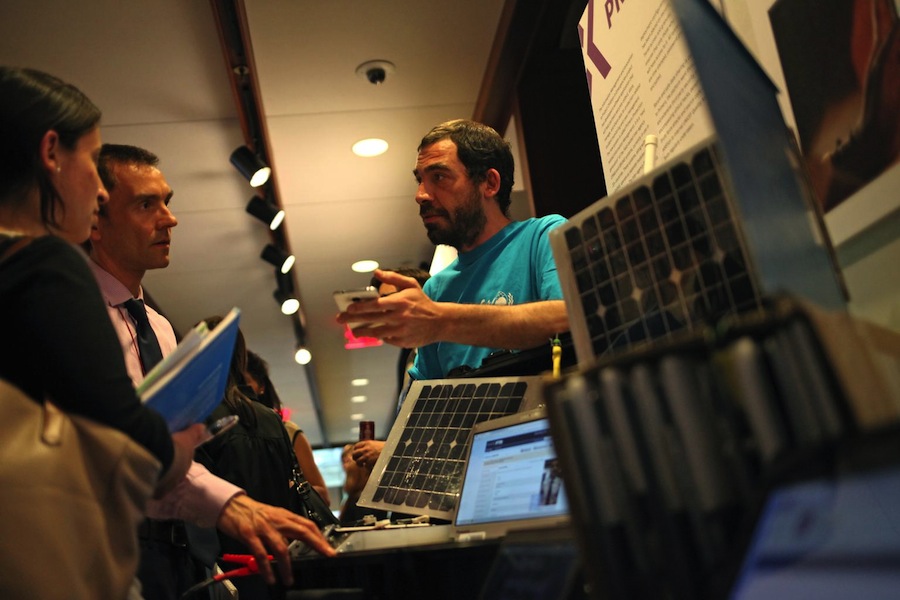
<box><xmin>454</xmin><ymin>409</ymin><xmax>569</xmax><ymax>533</ymax></box>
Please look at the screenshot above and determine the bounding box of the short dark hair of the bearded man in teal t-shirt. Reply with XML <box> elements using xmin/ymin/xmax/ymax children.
<box><xmin>418</xmin><ymin>119</ymin><xmax>516</xmax><ymax>216</ymax></box>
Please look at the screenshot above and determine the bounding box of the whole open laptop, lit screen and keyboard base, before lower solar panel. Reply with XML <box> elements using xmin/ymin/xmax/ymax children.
<box><xmin>314</xmin><ymin>407</ymin><xmax>569</xmax><ymax>554</ymax></box>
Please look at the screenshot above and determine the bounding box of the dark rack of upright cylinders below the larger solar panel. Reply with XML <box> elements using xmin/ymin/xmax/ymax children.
<box><xmin>545</xmin><ymin>300</ymin><xmax>897</xmax><ymax>599</ymax></box>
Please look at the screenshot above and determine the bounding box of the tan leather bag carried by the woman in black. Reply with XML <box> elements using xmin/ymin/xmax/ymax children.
<box><xmin>0</xmin><ymin>237</ymin><xmax>160</xmax><ymax>600</ymax></box>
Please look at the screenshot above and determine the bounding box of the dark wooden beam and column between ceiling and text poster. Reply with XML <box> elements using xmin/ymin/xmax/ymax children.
<box><xmin>473</xmin><ymin>0</ymin><xmax>606</xmax><ymax>217</ymax></box>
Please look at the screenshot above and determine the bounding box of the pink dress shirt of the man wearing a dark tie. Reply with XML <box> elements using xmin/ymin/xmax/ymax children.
<box><xmin>89</xmin><ymin>261</ymin><xmax>244</xmax><ymax>527</ymax></box>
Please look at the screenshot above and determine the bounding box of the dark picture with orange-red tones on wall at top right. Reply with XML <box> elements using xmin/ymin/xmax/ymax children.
<box><xmin>769</xmin><ymin>0</ymin><xmax>900</xmax><ymax>212</ymax></box>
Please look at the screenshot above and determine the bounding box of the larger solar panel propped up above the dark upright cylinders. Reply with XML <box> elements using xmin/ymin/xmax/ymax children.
<box><xmin>551</xmin><ymin>141</ymin><xmax>760</xmax><ymax>363</ymax></box>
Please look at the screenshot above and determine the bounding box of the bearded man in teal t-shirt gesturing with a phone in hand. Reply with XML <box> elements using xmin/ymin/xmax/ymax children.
<box><xmin>337</xmin><ymin>119</ymin><xmax>569</xmax><ymax>379</ymax></box>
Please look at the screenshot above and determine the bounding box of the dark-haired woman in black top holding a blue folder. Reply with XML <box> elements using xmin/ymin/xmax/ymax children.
<box><xmin>0</xmin><ymin>66</ymin><xmax>206</xmax><ymax>597</ymax></box>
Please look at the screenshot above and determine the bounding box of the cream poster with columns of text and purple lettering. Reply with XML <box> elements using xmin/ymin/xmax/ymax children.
<box><xmin>578</xmin><ymin>0</ymin><xmax>714</xmax><ymax>193</ymax></box>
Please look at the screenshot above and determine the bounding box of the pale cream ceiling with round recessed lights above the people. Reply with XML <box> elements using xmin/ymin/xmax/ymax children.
<box><xmin>0</xmin><ymin>0</ymin><xmax>529</xmax><ymax>446</ymax></box>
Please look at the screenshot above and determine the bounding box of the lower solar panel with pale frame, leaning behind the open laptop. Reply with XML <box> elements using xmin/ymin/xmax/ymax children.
<box><xmin>358</xmin><ymin>377</ymin><xmax>541</xmax><ymax>520</ymax></box>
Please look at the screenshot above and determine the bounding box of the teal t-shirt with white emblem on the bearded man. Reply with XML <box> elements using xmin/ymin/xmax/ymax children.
<box><xmin>409</xmin><ymin>215</ymin><xmax>566</xmax><ymax>379</ymax></box>
